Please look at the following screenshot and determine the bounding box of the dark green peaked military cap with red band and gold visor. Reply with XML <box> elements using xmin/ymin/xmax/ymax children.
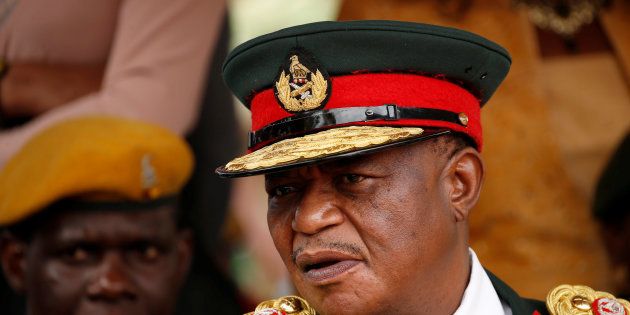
<box><xmin>217</xmin><ymin>21</ymin><xmax>511</xmax><ymax>177</ymax></box>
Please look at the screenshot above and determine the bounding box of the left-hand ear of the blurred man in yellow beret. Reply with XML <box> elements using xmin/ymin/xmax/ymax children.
<box><xmin>0</xmin><ymin>232</ymin><xmax>28</xmax><ymax>294</ymax></box>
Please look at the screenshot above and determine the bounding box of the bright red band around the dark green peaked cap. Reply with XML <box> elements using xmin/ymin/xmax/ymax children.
<box><xmin>250</xmin><ymin>73</ymin><xmax>482</xmax><ymax>151</ymax></box>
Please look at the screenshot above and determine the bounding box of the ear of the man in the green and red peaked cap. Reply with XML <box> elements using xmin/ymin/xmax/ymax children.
<box><xmin>444</xmin><ymin>147</ymin><xmax>484</xmax><ymax>222</ymax></box>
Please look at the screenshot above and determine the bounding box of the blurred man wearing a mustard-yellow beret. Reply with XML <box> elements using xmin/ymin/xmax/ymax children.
<box><xmin>0</xmin><ymin>117</ymin><xmax>193</xmax><ymax>315</ymax></box>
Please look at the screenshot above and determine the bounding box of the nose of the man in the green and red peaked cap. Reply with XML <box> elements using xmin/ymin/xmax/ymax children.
<box><xmin>291</xmin><ymin>183</ymin><xmax>344</xmax><ymax>234</ymax></box>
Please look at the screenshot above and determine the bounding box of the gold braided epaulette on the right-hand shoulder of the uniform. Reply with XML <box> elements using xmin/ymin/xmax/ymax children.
<box><xmin>547</xmin><ymin>284</ymin><xmax>630</xmax><ymax>315</ymax></box>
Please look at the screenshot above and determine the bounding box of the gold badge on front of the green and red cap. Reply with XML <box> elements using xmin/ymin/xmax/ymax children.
<box><xmin>274</xmin><ymin>50</ymin><xmax>330</xmax><ymax>113</ymax></box>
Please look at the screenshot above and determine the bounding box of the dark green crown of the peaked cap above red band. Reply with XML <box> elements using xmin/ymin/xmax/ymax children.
<box><xmin>223</xmin><ymin>21</ymin><xmax>511</xmax><ymax>106</ymax></box>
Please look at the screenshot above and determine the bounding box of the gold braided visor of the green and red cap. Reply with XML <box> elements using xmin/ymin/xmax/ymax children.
<box><xmin>217</xmin><ymin>126</ymin><xmax>424</xmax><ymax>176</ymax></box>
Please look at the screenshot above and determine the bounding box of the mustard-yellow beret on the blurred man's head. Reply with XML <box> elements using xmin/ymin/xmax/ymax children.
<box><xmin>0</xmin><ymin>116</ymin><xmax>194</xmax><ymax>226</ymax></box>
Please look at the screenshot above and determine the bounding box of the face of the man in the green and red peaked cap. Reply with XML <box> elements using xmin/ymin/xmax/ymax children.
<box><xmin>265</xmin><ymin>143</ymin><xmax>476</xmax><ymax>314</ymax></box>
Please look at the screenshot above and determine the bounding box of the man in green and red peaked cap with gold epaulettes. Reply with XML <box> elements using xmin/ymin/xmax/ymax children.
<box><xmin>217</xmin><ymin>21</ymin><xmax>630</xmax><ymax>315</ymax></box>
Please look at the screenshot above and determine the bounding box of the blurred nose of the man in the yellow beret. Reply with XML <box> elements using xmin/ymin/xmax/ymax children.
<box><xmin>87</xmin><ymin>251</ymin><xmax>136</xmax><ymax>301</ymax></box>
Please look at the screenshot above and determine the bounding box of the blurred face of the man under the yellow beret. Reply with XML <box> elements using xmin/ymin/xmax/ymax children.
<box><xmin>1</xmin><ymin>207</ymin><xmax>190</xmax><ymax>315</ymax></box>
